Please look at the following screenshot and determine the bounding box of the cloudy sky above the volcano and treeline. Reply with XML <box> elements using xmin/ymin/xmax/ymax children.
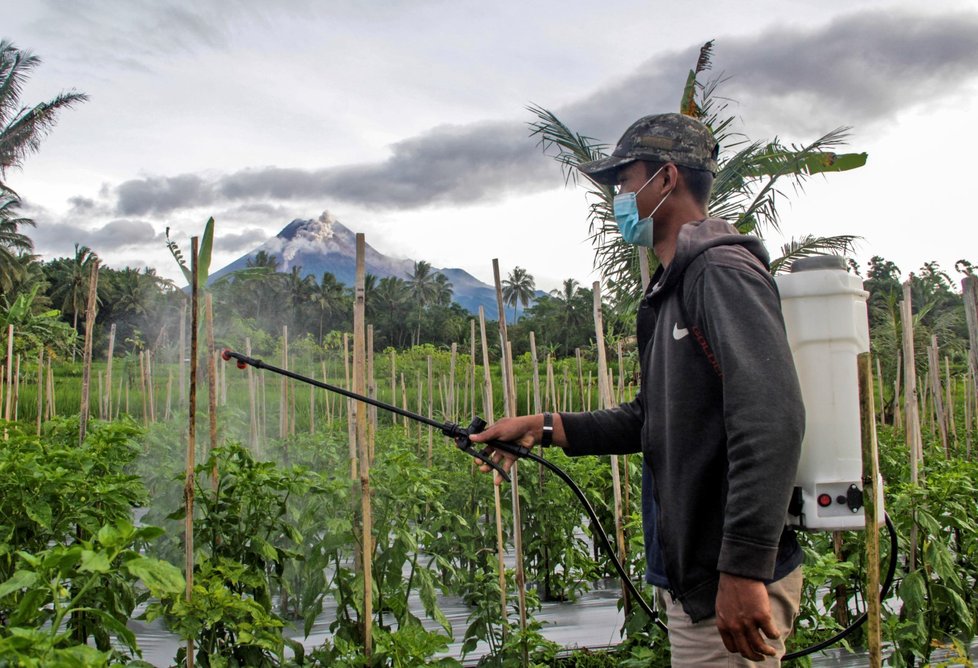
<box><xmin>0</xmin><ymin>0</ymin><xmax>978</xmax><ymax>290</ymax></box>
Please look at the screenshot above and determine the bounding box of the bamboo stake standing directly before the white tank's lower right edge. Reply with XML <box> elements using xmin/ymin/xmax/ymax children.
<box><xmin>858</xmin><ymin>353</ymin><xmax>880</xmax><ymax>668</ymax></box>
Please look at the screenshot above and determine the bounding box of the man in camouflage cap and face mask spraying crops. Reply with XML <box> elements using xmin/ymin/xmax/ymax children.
<box><xmin>472</xmin><ymin>114</ymin><xmax>804</xmax><ymax>666</ymax></box>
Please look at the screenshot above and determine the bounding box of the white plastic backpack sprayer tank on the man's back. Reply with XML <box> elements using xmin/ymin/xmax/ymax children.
<box><xmin>775</xmin><ymin>255</ymin><xmax>883</xmax><ymax>531</ymax></box>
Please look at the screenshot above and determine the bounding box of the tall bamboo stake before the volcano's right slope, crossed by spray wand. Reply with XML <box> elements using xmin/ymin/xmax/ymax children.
<box><xmin>353</xmin><ymin>233</ymin><xmax>373</xmax><ymax>659</ymax></box>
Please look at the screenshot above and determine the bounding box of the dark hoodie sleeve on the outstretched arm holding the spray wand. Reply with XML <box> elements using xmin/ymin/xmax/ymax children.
<box><xmin>560</xmin><ymin>391</ymin><xmax>644</xmax><ymax>457</ymax></box>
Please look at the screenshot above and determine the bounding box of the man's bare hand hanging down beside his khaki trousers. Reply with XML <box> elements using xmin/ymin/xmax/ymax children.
<box><xmin>716</xmin><ymin>573</ymin><xmax>781</xmax><ymax>661</ymax></box>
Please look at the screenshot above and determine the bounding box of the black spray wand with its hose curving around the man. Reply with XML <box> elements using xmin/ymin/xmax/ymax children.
<box><xmin>222</xmin><ymin>350</ymin><xmax>897</xmax><ymax>661</ymax></box>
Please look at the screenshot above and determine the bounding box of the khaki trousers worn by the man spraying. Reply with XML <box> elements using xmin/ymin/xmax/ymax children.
<box><xmin>656</xmin><ymin>566</ymin><xmax>802</xmax><ymax>668</ymax></box>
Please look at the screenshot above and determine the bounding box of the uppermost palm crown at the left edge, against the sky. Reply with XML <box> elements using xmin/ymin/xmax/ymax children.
<box><xmin>0</xmin><ymin>40</ymin><xmax>88</xmax><ymax>187</ymax></box>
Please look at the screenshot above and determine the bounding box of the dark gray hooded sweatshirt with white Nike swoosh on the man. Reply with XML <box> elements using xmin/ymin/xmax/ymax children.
<box><xmin>561</xmin><ymin>219</ymin><xmax>805</xmax><ymax>621</ymax></box>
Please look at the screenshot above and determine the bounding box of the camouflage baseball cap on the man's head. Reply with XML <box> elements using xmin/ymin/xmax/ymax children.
<box><xmin>578</xmin><ymin>113</ymin><xmax>719</xmax><ymax>186</ymax></box>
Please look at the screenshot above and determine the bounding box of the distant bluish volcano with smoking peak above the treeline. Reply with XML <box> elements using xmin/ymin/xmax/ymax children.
<box><xmin>209</xmin><ymin>211</ymin><xmax>544</xmax><ymax>321</ymax></box>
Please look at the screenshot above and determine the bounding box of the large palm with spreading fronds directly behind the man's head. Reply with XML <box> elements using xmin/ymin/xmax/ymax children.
<box><xmin>529</xmin><ymin>41</ymin><xmax>866</xmax><ymax>311</ymax></box>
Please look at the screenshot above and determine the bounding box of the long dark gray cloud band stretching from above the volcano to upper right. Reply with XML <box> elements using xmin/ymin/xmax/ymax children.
<box><xmin>101</xmin><ymin>10</ymin><xmax>978</xmax><ymax>216</ymax></box>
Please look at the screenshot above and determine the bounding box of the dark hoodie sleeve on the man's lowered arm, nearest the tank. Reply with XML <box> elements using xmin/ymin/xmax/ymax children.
<box><xmin>691</xmin><ymin>258</ymin><xmax>805</xmax><ymax>579</ymax></box>
